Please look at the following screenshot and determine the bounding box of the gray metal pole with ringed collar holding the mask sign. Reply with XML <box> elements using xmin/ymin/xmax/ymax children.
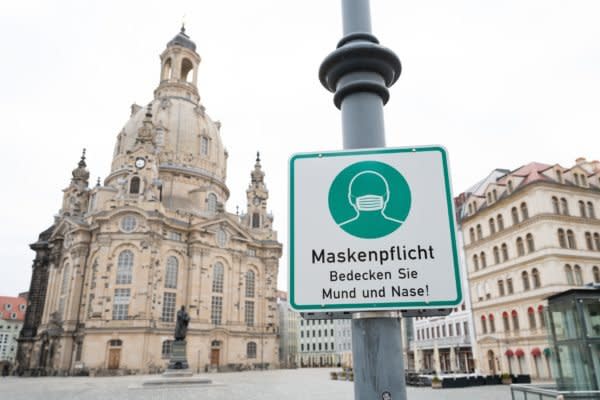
<box><xmin>319</xmin><ymin>0</ymin><xmax>406</xmax><ymax>400</ymax></box>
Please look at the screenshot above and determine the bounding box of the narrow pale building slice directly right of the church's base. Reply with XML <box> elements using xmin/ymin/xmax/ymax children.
<box><xmin>277</xmin><ymin>290</ymin><xmax>301</xmax><ymax>368</ymax></box>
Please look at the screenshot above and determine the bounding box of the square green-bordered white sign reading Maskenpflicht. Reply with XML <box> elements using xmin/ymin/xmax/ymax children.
<box><xmin>289</xmin><ymin>146</ymin><xmax>462</xmax><ymax>311</ymax></box>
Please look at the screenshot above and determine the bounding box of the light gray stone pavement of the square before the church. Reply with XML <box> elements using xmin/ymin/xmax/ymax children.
<box><xmin>0</xmin><ymin>369</ymin><xmax>510</xmax><ymax>400</ymax></box>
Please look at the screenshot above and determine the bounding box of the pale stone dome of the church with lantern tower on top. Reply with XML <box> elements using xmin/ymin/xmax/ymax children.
<box><xmin>107</xmin><ymin>29</ymin><xmax>229</xmax><ymax>208</ymax></box>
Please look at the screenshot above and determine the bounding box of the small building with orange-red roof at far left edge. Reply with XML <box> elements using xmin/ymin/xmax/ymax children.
<box><xmin>0</xmin><ymin>295</ymin><xmax>27</xmax><ymax>374</ymax></box>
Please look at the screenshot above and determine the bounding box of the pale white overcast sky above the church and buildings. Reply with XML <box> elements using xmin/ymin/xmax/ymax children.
<box><xmin>0</xmin><ymin>0</ymin><xmax>600</xmax><ymax>295</ymax></box>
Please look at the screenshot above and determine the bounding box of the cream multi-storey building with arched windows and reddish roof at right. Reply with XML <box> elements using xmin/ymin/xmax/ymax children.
<box><xmin>460</xmin><ymin>158</ymin><xmax>600</xmax><ymax>379</ymax></box>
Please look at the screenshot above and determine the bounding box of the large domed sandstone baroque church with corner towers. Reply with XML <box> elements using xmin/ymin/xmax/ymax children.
<box><xmin>17</xmin><ymin>27</ymin><xmax>282</xmax><ymax>375</ymax></box>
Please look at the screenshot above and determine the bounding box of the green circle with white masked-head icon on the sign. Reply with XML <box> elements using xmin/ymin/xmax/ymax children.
<box><xmin>329</xmin><ymin>161</ymin><xmax>411</xmax><ymax>239</ymax></box>
